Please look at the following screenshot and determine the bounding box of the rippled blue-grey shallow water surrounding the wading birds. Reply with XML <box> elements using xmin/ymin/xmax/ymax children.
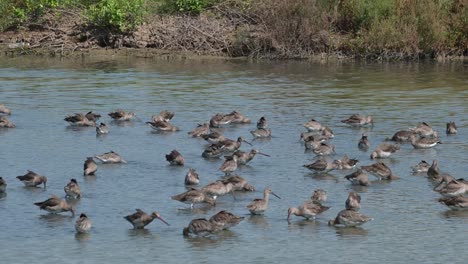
<box><xmin>0</xmin><ymin>58</ymin><xmax>468</xmax><ymax>263</ymax></box>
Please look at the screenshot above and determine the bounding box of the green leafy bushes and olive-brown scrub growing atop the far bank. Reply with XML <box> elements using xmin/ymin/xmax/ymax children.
<box><xmin>0</xmin><ymin>0</ymin><xmax>468</xmax><ymax>58</ymax></box>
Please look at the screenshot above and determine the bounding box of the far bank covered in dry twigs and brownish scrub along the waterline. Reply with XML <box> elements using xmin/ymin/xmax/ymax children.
<box><xmin>0</xmin><ymin>0</ymin><xmax>468</xmax><ymax>61</ymax></box>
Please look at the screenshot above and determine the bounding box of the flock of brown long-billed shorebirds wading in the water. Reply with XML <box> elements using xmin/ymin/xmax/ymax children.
<box><xmin>0</xmin><ymin>101</ymin><xmax>468</xmax><ymax>236</ymax></box>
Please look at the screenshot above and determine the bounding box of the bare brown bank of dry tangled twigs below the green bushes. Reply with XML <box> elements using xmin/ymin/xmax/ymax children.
<box><xmin>0</xmin><ymin>10</ymin><xmax>467</xmax><ymax>62</ymax></box>
